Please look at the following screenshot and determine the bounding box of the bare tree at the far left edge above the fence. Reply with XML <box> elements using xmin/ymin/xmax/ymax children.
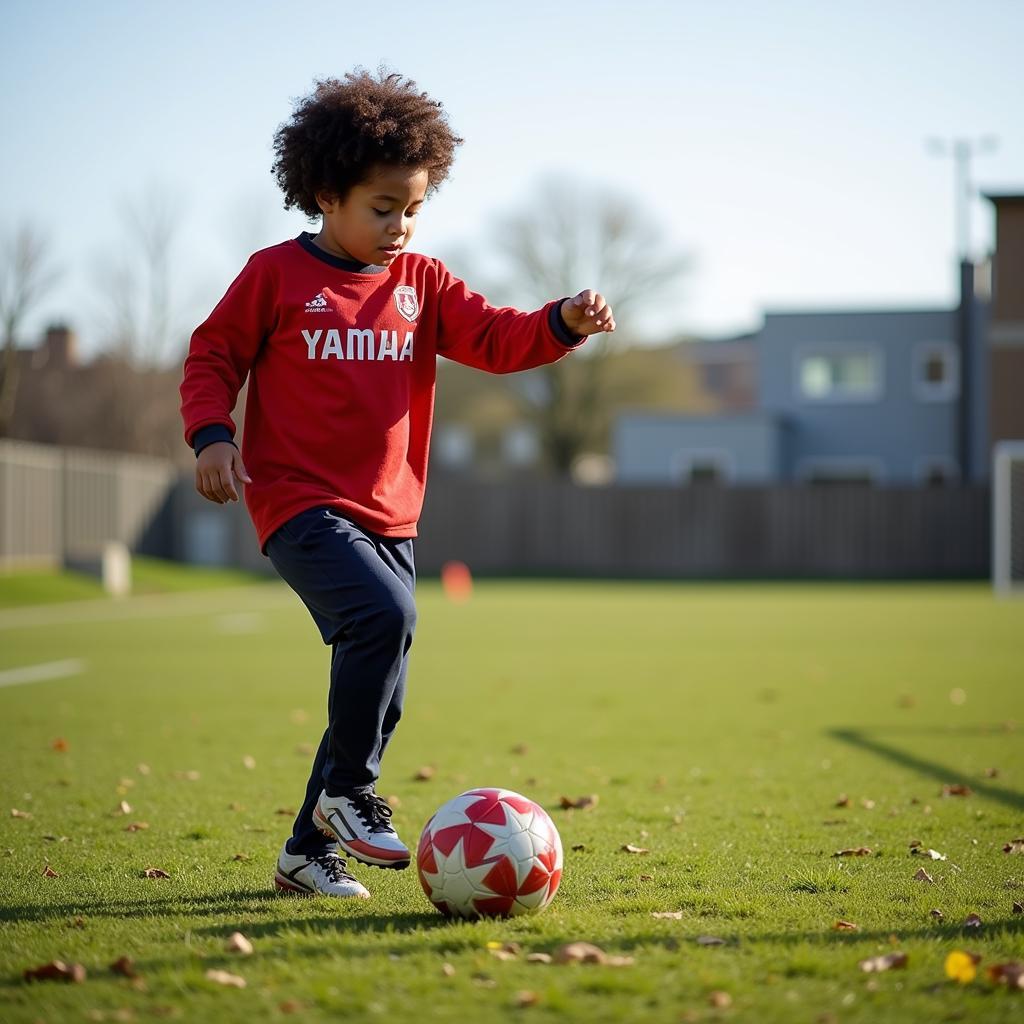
<box><xmin>0</xmin><ymin>224</ymin><xmax>56</xmax><ymax>437</ymax></box>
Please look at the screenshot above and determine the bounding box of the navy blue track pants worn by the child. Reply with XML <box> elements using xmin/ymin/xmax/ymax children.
<box><xmin>266</xmin><ymin>508</ymin><xmax>416</xmax><ymax>855</ymax></box>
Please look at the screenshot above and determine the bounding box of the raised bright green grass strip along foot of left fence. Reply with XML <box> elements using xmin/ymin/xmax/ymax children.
<box><xmin>0</xmin><ymin>555</ymin><xmax>263</xmax><ymax>608</ymax></box>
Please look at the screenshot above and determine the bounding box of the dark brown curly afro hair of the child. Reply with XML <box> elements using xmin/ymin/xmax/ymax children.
<box><xmin>271</xmin><ymin>68</ymin><xmax>462</xmax><ymax>219</ymax></box>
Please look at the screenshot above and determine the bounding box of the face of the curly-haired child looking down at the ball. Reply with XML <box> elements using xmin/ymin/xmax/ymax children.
<box><xmin>316</xmin><ymin>166</ymin><xmax>428</xmax><ymax>266</ymax></box>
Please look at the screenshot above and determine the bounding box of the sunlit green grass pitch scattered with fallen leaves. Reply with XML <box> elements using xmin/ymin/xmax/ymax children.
<box><xmin>0</xmin><ymin>581</ymin><xmax>1024</xmax><ymax>1024</ymax></box>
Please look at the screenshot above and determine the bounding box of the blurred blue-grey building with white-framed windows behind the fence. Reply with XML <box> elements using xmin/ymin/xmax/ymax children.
<box><xmin>614</xmin><ymin>299</ymin><xmax>988</xmax><ymax>484</ymax></box>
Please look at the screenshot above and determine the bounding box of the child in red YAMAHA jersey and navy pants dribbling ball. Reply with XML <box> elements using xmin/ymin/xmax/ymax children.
<box><xmin>181</xmin><ymin>72</ymin><xmax>615</xmax><ymax>898</ymax></box>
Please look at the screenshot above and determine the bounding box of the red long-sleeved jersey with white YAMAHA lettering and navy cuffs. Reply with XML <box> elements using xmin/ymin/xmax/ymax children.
<box><xmin>180</xmin><ymin>234</ymin><xmax>585</xmax><ymax>550</ymax></box>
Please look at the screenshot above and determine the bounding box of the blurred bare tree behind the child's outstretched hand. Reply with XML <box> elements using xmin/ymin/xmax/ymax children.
<box><xmin>468</xmin><ymin>180</ymin><xmax>690</xmax><ymax>475</ymax></box>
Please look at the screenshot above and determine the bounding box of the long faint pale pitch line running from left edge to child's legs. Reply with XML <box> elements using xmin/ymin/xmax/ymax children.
<box><xmin>0</xmin><ymin>583</ymin><xmax>301</xmax><ymax>630</ymax></box>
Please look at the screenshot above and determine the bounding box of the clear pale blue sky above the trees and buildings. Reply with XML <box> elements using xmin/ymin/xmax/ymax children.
<box><xmin>0</xmin><ymin>0</ymin><xmax>1024</xmax><ymax>358</ymax></box>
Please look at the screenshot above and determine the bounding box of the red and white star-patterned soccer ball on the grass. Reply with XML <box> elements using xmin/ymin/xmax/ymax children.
<box><xmin>416</xmin><ymin>790</ymin><xmax>562</xmax><ymax>918</ymax></box>
